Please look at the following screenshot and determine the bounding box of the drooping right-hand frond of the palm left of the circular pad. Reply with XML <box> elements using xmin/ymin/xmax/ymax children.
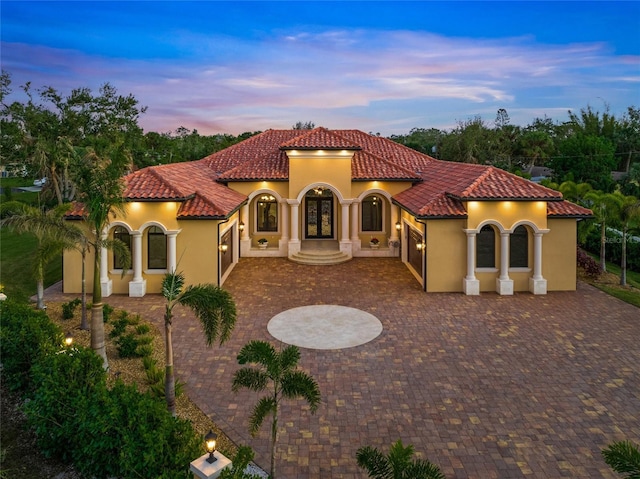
<box><xmin>178</xmin><ymin>284</ymin><xmax>237</xmax><ymax>346</ymax></box>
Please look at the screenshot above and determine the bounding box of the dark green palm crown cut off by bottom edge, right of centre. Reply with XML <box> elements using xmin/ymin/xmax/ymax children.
<box><xmin>356</xmin><ymin>439</ymin><xmax>445</xmax><ymax>479</ymax></box>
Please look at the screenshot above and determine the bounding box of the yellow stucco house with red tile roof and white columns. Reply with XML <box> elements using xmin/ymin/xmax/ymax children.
<box><xmin>63</xmin><ymin>128</ymin><xmax>591</xmax><ymax>297</ymax></box>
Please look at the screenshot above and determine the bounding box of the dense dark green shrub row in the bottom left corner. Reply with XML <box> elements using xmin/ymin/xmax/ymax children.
<box><xmin>0</xmin><ymin>301</ymin><xmax>202</xmax><ymax>479</ymax></box>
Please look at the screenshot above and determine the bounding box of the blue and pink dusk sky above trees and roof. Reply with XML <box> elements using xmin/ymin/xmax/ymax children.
<box><xmin>0</xmin><ymin>0</ymin><xmax>640</xmax><ymax>136</ymax></box>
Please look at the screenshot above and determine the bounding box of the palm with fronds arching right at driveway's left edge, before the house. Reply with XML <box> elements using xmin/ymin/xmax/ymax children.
<box><xmin>162</xmin><ymin>272</ymin><xmax>236</xmax><ymax>416</ymax></box>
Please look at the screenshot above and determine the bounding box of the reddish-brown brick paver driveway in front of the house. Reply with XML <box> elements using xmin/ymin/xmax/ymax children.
<box><xmin>51</xmin><ymin>258</ymin><xmax>640</xmax><ymax>479</ymax></box>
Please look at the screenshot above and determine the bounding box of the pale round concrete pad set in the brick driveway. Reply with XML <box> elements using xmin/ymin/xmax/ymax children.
<box><xmin>267</xmin><ymin>305</ymin><xmax>382</xmax><ymax>349</ymax></box>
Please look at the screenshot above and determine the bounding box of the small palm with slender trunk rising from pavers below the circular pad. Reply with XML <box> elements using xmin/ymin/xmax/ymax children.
<box><xmin>231</xmin><ymin>341</ymin><xmax>320</xmax><ymax>479</ymax></box>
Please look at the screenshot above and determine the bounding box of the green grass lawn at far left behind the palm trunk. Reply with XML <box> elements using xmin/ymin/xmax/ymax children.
<box><xmin>0</xmin><ymin>228</ymin><xmax>62</xmax><ymax>301</ymax></box>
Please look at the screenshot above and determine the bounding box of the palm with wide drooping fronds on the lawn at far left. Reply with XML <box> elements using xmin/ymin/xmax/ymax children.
<box><xmin>2</xmin><ymin>201</ymin><xmax>83</xmax><ymax>309</ymax></box>
